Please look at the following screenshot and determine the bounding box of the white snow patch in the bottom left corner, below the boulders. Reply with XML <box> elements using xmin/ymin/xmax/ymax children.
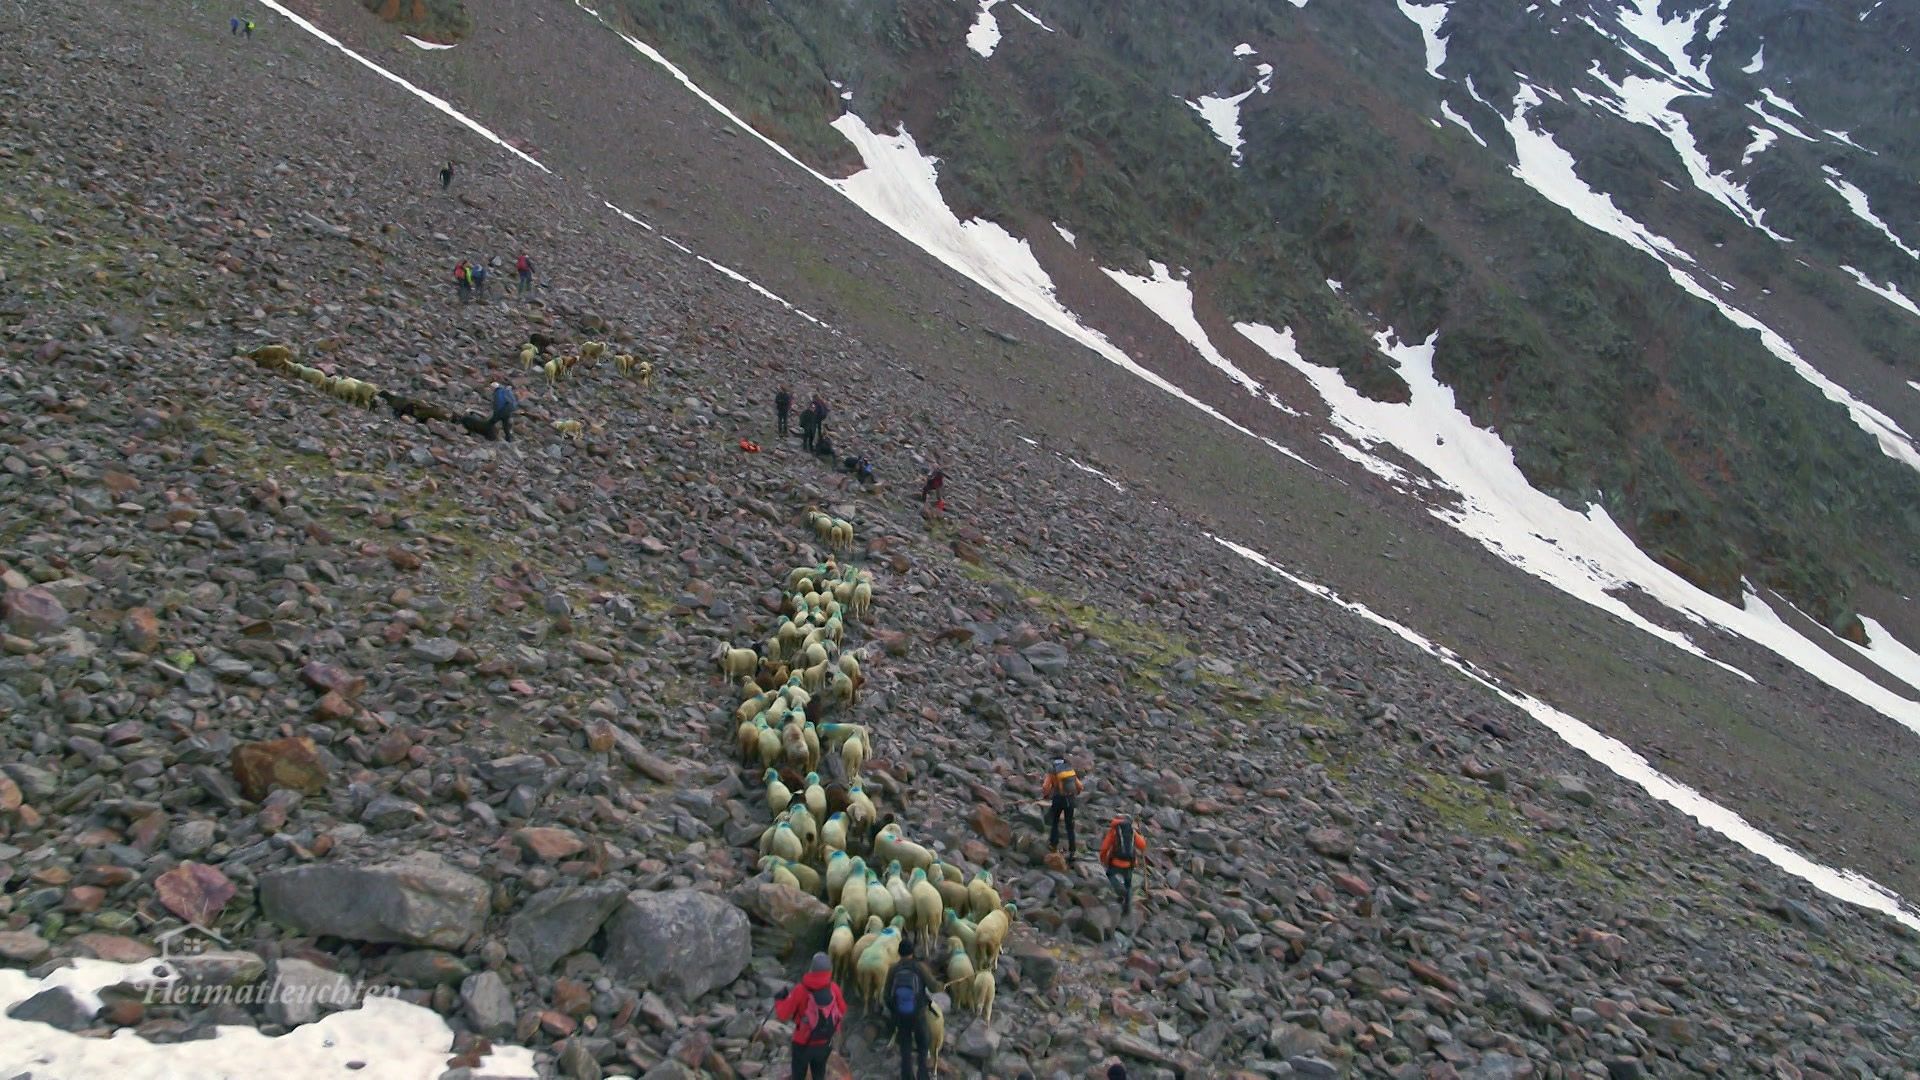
<box><xmin>0</xmin><ymin>959</ymin><xmax>538</xmax><ymax>1080</ymax></box>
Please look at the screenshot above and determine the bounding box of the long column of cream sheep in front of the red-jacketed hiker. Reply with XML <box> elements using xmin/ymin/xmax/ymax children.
<box><xmin>716</xmin><ymin>511</ymin><xmax>1016</xmax><ymax>1070</ymax></box>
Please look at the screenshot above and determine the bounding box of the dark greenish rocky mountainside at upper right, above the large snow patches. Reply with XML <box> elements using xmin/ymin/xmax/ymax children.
<box><xmin>603</xmin><ymin>0</ymin><xmax>1920</xmax><ymax>634</ymax></box>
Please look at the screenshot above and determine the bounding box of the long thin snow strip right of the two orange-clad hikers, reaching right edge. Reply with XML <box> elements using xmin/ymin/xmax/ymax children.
<box><xmin>1208</xmin><ymin>532</ymin><xmax>1920</xmax><ymax>930</ymax></box>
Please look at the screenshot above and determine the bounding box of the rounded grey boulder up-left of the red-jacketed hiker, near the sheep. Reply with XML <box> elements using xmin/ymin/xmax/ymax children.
<box><xmin>607</xmin><ymin>890</ymin><xmax>753</xmax><ymax>1001</ymax></box>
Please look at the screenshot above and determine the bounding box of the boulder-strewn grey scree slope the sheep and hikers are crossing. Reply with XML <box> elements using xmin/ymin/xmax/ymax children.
<box><xmin>0</xmin><ymin>0</ymin><xmax>1920</xmax><ymax>1078</ymax></box>
